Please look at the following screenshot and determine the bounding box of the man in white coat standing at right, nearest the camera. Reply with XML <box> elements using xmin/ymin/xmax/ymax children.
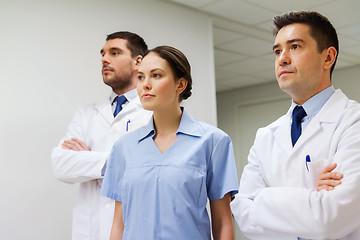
<box><xmin>231</xmin><ymin>11</ymin><xmax>360</xmax><ymax>240</ymax></box>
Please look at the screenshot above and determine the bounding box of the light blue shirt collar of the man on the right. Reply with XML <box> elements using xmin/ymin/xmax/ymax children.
<box><xmin>291</xmin><ymin>85</ymin><xmax>335</xmax><ymax>119</ymax></box>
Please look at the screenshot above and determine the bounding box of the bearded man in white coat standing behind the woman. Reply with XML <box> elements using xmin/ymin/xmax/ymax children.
<box><xmin>51</xmin><ymin>32</ymin><xmax>151</xmax><ymax>240</ymax></box>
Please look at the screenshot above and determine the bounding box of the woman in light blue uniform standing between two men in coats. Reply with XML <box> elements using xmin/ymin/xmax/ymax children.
<box><xmin>101</xmin><ymin>46</ymin><xmax>238</xmax><ymax>240</ymax></box>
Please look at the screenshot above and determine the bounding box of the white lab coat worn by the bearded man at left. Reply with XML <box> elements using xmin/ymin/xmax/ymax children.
<box><xmin>51</xmin><ymin>90</ymin><xmax>152</xmax><ymax>240</ymax></box>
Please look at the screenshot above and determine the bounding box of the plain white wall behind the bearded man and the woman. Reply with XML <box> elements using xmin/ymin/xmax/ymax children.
<box><xmin>0</xmin><ymin>0</ymin><xmax>216</xmax><ymax>240</ymax></box>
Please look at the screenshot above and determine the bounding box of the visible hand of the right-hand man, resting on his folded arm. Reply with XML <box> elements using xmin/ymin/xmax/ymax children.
<box><xmin>315</xmin><ymin>163</ymin><xmax>343</xmax><ymax>191</ymax></box>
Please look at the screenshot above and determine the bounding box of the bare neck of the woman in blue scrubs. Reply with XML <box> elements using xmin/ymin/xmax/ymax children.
<box><xmin>154</xmin><ymin>106</ymin><xmax>182</xmax><ymax>135</ymax></box>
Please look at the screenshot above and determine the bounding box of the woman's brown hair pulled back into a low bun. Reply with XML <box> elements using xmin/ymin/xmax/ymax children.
<box><xmin>144</xmin><ymin>46</ymin><xmax>192</xmax><ymax>101</ymax></box>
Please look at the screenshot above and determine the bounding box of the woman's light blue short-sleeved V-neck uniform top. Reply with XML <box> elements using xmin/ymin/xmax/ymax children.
<box><xmin>101</xmin><ymin>110</ymin><xmax>238</xmax><ymax>240</ymax></box>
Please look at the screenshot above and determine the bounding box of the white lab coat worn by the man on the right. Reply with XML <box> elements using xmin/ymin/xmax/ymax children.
<box><xmin>231</xmin><ymin>90</ymin><xmax>360</xmax><ymax>240</ymax></box>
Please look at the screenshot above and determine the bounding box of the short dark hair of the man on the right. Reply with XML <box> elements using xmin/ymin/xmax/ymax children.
<box><xmin>273</xmin><ymin>11</ymin><xmax>339</xmax><ymax>76</ymax></box>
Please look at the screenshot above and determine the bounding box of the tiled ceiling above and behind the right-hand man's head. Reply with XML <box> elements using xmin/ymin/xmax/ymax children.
<box><xmin>162</xmin><ymin>0</ymin><xmax>360</xmax><ymax>92</ymax></box>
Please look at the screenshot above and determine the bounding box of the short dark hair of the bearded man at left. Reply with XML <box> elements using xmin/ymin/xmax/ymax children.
<box><xmin>106</xmin><ymin>31</ymin><xmax>148</xmax><ymax>57</ymax></box>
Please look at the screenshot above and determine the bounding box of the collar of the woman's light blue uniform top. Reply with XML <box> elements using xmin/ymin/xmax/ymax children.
<box><xmin>139</xmin><ymin>107</ymin><xmax>202</xmax><ymax>142</ymax></box>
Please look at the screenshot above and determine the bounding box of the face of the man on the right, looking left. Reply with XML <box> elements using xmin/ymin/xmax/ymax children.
<box><xmin>273</xmin><ymin>23</ymin><xmax>328</xmax><ymax>104</ymax></box>
